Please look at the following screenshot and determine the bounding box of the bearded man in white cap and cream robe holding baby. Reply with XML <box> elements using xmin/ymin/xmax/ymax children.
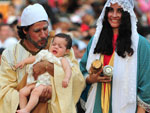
<box><xmin>0</xmin><ymin>4</ymin><xmax>84</xmax><ymax>113</ymax></box>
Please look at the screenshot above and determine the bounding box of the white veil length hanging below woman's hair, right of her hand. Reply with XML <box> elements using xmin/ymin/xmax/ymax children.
<box><xmin>112</xmin><ymin>33</ymin><xmax>138</xmax><ymax>113</ymax></box>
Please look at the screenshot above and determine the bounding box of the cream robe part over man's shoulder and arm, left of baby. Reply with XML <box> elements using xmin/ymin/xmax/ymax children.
<box><xmin>0</xmin><ymin>43</ymin><xmax>30</xmax><ymax>113</ymax></box>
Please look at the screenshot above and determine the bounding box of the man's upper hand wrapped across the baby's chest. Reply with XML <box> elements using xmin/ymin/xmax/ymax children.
<box><xmin>33</xmin><ymin>61</ymin><xmax>54</xmax><ymax>80</ymax></box>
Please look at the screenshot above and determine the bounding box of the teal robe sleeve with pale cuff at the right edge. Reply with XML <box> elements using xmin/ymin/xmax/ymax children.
<box><xmin>137</xmin><ymin>36</ymin><xmax>150</xmax><ymax>112</ymax></box>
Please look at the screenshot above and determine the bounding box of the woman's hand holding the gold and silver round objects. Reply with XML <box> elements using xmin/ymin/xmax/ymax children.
<box><xmin>86</xmin><ymin>70</ymin><xmax>111</xmax><ymax>84</ymax></box>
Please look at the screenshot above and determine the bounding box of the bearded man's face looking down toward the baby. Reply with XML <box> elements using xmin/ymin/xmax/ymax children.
<box><xmin>27</xmin><ymin>21</ymin><xmax>48</xmax><ymax>47</ymax></box>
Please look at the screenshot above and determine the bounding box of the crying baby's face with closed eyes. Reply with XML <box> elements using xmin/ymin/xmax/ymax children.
<box><xmin>50</xmin><ymin>37</ymin><xmax>67</xmax><ymax>57</ymax></box>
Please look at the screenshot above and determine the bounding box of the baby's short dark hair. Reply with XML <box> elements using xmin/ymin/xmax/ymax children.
<box><xmin>54</xmin><ymin>33</ymin><xmax>72</xmax><ymax>49</ymax></box>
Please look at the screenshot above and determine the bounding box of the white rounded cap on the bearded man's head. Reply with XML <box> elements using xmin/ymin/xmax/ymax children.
<box><xmin>21</xmin><ymin>3</ymin><xmax>48</xmax><ymax>26</ymax></box>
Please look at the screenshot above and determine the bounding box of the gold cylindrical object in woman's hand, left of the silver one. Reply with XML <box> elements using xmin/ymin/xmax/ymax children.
<box><xmin>89</xmin><ymin>59</ymin><xmax>102</xmax><ymax>74</ymax></box>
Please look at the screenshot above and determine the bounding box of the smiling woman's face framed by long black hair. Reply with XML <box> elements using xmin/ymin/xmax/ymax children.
<box><xmin>108</xmin><ymin>3</ymin><xmax>123</xmax><ymax>33</ymax></box>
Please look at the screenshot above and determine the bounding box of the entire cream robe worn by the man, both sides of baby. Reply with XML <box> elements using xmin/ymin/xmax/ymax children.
<box><xmin>0</xmin><ymin>43</ymin><xmax>85</xmax><ymax>113</ymax></box>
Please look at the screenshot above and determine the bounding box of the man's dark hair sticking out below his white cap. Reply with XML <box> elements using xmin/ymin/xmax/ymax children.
<box><xmin>17</xmin><ymin>26</ymin><xmax>30</xmax><ymax>39</ymax></box>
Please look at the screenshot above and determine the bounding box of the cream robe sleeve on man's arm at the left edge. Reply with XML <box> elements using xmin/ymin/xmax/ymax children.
<box><xmin>0</xmin><ymin>50</ymin><xmax>19</xmax><ymax>113</ymax></box>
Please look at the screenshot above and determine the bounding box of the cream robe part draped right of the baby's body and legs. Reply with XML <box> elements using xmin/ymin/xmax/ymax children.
<box><xmin>51</xmin><ymin>48</ymin><xmax>85</xmax><ymax>113</ymax></box>
